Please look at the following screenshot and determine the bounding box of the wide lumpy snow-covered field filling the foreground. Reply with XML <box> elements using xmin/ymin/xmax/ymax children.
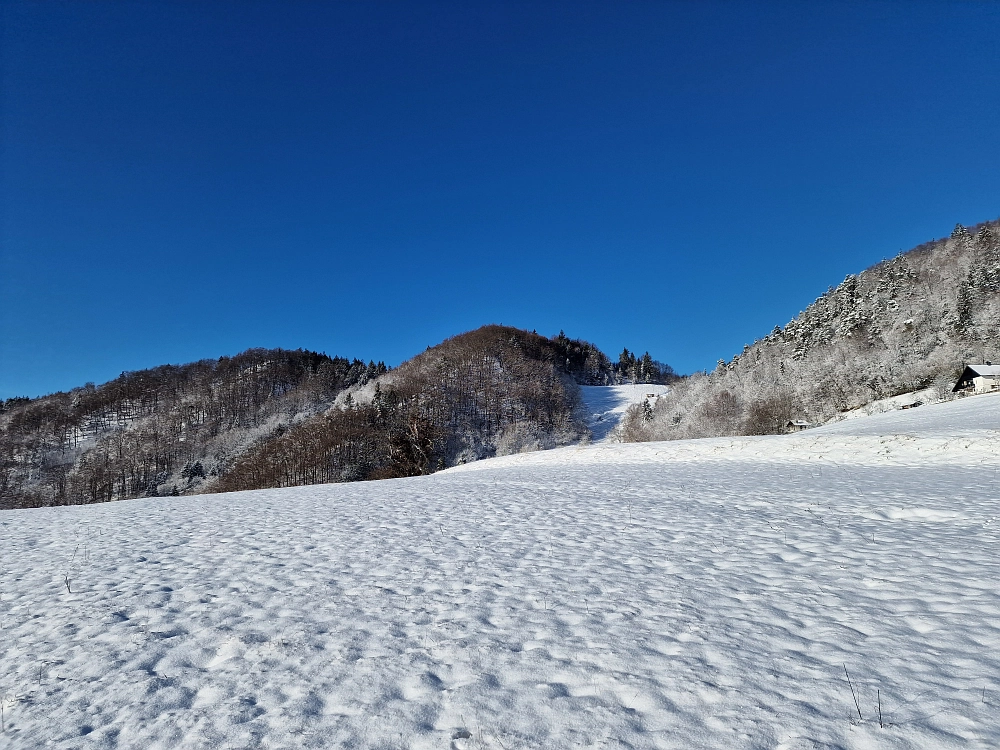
<box><xmin>0</xmin><ymin>396</ymin><xmax>1000</xmax><ymax>750</ymax></box>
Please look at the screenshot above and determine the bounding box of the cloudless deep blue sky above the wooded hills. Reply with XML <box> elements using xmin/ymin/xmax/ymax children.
<box><xmin>0</xmin><ymin>0</ymin><xmax>1000</xmax><ymax>397</ymax></box>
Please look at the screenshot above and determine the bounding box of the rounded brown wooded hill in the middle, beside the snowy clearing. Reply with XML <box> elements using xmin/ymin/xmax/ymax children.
<box><xmin>213</xmin><ymin>325</ymin><xmax>676</xmax><ymax>491</ymax></box>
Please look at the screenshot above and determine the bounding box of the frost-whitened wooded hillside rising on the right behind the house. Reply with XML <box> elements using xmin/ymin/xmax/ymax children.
<box><xmin>623</xmin><ymin>217</ymin><xmax>1000</xmax><ymax>440</ymax></box>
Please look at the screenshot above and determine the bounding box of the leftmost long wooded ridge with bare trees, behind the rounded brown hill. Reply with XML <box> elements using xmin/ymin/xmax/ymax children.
<box><xmin>0</xmin><ymin>349</ymin><xmax>387</xmax><ymax>507</ymax></box>
